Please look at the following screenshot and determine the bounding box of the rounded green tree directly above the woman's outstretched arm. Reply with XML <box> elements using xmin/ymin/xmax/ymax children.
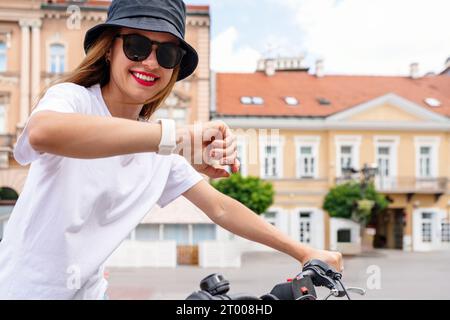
<box><xmin>211</xmin><ymin>173</ymin><xmax>275</xmax><ymax>214</ymax></box>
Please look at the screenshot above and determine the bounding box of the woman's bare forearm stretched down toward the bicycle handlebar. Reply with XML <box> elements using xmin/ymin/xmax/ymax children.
<box><xmin>211</xmin><ymin>196</ymin><xmax>310</xmax><ymax>261</ymax></box>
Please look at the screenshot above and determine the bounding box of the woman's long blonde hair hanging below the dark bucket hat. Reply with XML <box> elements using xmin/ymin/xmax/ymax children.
<box><xmin>37</xmin><ymin>27</ymin><xmax>180</xmax><ymax>120</ymax></box>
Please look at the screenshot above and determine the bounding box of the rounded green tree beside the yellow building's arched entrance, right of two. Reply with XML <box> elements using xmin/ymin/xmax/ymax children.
<box><xmin>323</xmin><ymin>181</ymin><xmax>389</xmax><ymax>226</ymax></box>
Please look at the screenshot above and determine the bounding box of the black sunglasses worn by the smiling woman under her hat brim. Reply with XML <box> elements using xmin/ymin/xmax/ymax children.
<box><xmin>116</xmin><ymin>33</ymin><xmax>186</xmax><ymax>69</ymax></box>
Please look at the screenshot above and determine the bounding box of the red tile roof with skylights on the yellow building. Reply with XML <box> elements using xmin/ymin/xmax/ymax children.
<box><xmin>216</xmin><ymin>71</ymin><xmax>450</xmax><ymax>117</ymax></box>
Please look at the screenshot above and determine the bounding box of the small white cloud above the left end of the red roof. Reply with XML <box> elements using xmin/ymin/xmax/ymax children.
<box><xmin>211</xmin><ymin>27</ymin><xmax>261</xmax><ymax>72</ymax></box>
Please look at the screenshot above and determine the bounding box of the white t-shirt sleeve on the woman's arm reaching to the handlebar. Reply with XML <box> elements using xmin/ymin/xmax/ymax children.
<box><xmin>157</xmin><ymin>155</ymin><xmax>203</xmax><ymax>208</ymax></box>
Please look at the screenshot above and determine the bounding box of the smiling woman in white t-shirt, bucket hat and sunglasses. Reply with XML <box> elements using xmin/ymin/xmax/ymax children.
<box><xmin>0</xmin><ymin>0</ymin><xmax>342</xmax><ymax>299</ymax></box>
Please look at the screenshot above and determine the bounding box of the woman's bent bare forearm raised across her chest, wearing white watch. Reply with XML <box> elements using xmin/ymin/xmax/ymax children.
<box><xmin>29</xmin><ymin>112</ymin><xmax>161</xmax><ymax>159</ymax></box>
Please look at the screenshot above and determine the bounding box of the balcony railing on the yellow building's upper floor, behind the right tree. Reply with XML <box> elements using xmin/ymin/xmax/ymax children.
<box><xmin>336</xmin><ymin>176</ymin><xmax>449</xmax><ymax>194</ymax></box>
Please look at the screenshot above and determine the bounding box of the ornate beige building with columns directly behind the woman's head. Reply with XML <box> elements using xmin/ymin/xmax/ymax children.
<box><xmin>0</xmin><ymin>0</ymin><xmax>210</xmax><ymax>252</ymax></box>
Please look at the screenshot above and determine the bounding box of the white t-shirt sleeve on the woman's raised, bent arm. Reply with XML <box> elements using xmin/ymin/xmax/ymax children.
<box><xmin>13</xmin><ymin>82</ymin><xmax>82</xmax><ymax>166</ymax></box>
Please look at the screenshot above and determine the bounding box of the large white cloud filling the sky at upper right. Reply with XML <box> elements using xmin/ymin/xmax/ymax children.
<box><xmin>278</xmin><ymin>0</ymin><xmax>450</xmax><ymax>74</ymax></box>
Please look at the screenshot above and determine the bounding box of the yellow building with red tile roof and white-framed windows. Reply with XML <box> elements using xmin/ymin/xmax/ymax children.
<box><xmin>212</xmin><ymin>59</ymin><xmax>450</xmax><ymax>251</ymax></box>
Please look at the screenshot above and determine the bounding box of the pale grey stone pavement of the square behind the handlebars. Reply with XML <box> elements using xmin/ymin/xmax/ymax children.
<box><xmin>107</xmin><ymin>250</ymin><xmax>450</xmax><ymax>300</ymax></box>
